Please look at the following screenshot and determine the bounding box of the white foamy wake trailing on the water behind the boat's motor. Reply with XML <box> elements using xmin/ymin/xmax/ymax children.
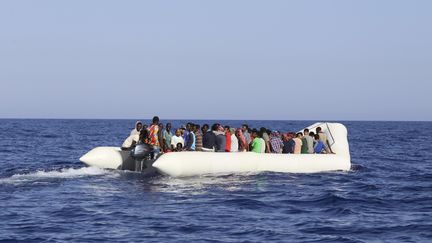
<box><xmin>0</xmin><ymin>167</ymin><xmax>113</xmax><ymax>184</ymax></box>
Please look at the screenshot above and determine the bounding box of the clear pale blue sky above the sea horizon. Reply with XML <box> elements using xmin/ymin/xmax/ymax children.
<box><xmin>0</xmin><ymin>0</ymin><xmax>432</xmax><ymax>120</ymax></box>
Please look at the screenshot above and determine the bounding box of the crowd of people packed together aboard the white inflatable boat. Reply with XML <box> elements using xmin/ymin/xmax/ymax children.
<box><xmin>122</xmin><ymin>116</ymin><xmax>333</xmax><ymax>158</ymax></box>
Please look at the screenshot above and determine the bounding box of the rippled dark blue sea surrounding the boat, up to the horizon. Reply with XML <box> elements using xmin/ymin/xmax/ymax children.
<box><xmin>0</xmin><ymin>119</ymin><xmax>432</xmax><ymax>242</ymax></box>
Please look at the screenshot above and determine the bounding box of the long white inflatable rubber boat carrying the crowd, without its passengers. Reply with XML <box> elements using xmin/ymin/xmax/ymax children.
<box><xmin>80</xmin><ymin>123</ymin><xmax>351</xmax><ymax>177</ymax></box>
